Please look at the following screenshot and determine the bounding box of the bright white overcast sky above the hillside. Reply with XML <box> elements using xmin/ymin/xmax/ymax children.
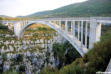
<box><xmin>0</xmin><ymin>0</ymin><xmax>86</xmax><ymax>17</ymax></box>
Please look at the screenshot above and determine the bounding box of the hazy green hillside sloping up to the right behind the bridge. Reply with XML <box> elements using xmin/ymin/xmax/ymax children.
<box><xmin>25</xmin><ymin>0</ymin><xmax>111</xmax><ymax>18</ymax></box>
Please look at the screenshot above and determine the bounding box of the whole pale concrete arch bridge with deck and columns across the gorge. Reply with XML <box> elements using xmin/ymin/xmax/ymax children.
<box><xmin>2</xmin><ymin>17</ymin><xmax>111</xmax><ymax>56</ymax></box>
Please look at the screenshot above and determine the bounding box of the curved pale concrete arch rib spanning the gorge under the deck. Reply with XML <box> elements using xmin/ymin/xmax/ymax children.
<box><xmin>18</xmin><ymin>21</ymin><xmax>86</xmax><ymax>56</ymax></box>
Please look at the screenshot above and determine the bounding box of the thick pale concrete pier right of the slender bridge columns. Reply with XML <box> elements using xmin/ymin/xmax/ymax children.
<box><xmin>89</xmin><ymin>19</ymin><xmax>101</xmax><ymax>48</ymax></box>
